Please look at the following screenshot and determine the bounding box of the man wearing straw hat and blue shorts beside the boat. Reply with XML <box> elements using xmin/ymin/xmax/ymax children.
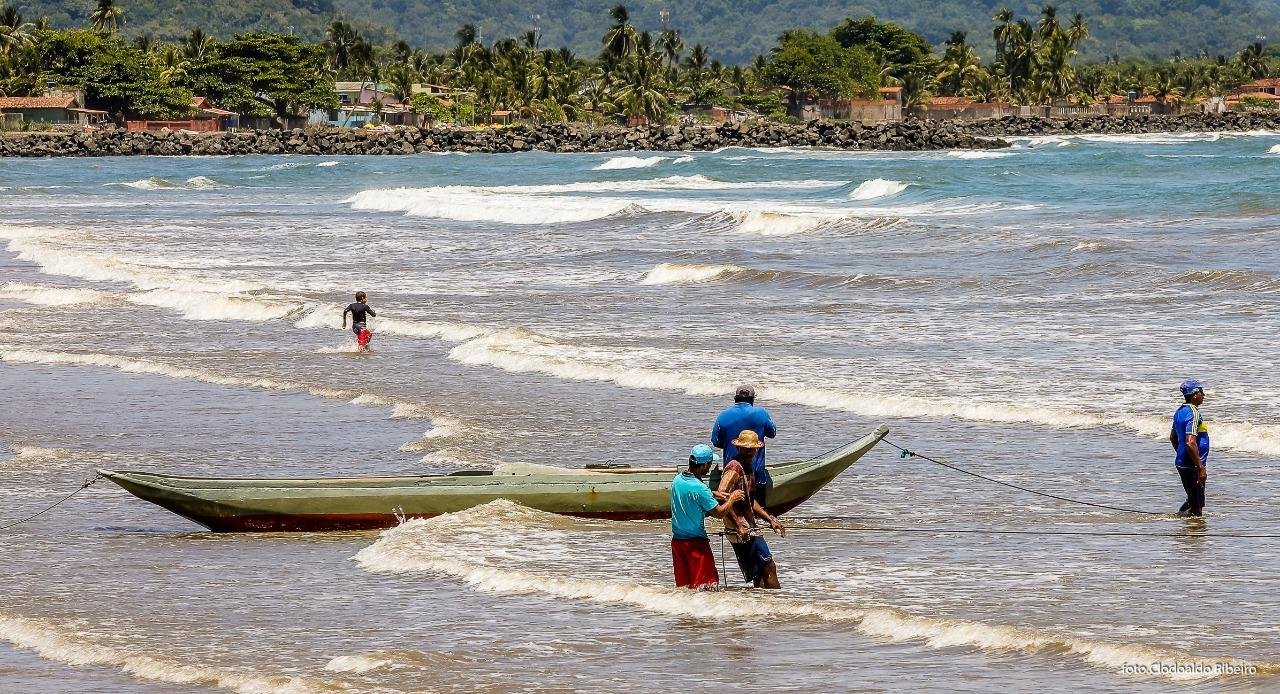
<box><xmin>717</xmin><ymin>429</ymin><xmax>787</xmax><ymax>588</ymax></box>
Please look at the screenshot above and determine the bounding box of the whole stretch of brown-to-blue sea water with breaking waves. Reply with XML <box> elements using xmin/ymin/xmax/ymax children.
<box><xmin>0</xmin><ymin>133</ymin><xmax>1280</xmax><ymax>693</ymax></box>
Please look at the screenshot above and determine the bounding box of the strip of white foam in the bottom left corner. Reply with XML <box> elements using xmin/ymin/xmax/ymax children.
<box><xmin>0</xmin><ymin>613</ymin><xmax>348</xmax><ymax>694</ymax></box>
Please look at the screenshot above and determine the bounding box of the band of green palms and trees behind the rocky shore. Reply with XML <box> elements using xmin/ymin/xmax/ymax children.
<box><xmin>0</xmin><ymin>0</ymin><xmax>1275</xmax><ymax>122</ymax></box>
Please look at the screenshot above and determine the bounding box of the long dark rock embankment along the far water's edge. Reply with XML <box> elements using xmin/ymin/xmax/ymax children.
<box><xmin>0</xmin><ymin>113</ymin><xmax>1280</xmax><ymax>157</ymax></box>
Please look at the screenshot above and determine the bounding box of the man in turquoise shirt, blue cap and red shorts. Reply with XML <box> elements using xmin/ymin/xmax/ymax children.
<box><xmin>671</xmin><ymin>443</ymin><xmax>744</xmax><ymax>588</ymax></box>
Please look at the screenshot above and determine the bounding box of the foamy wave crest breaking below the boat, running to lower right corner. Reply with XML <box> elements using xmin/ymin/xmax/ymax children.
<box><xmin>355</xmin><ymin>501</ymin><xmax>1280</xmax><ymax>680</ymax></box>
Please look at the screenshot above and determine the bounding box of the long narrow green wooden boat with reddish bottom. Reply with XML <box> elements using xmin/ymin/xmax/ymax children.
<box><xmin>99</xmin><ymin>426</ymin><xmax>888</xmax><ymax>531</ymax></box>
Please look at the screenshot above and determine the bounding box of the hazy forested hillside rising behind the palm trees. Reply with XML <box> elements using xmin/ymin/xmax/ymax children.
<box><xmin>14</xmin><ymin>0</ymin><xmax>1280</xmax><ymax>63</ymax></box>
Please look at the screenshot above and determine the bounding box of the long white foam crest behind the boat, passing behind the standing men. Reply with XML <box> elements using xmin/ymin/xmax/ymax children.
<box><xmin>449</xmin><ymin>328</ymin><xmax>1280</xmax><ymax>456</ymax></box>
